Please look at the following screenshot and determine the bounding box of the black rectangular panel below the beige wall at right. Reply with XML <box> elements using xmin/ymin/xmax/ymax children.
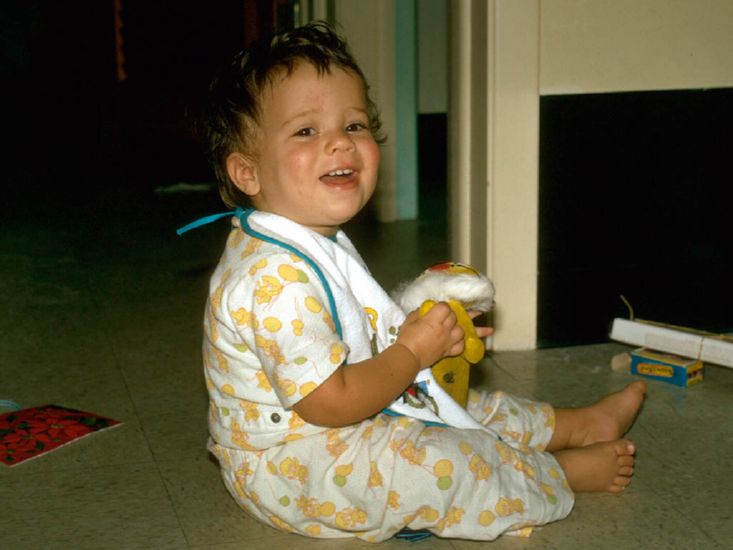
<box><xmin>538</xmin><ymin>89</ymin><xmax>733</xmax><ymax>347</ymax></box>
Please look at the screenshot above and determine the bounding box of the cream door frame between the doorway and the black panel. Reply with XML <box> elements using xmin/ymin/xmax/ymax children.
<box><xmin>448</xmin><ymin>0</ymin><xmax>540</xmax><ymax>349</ymax></box>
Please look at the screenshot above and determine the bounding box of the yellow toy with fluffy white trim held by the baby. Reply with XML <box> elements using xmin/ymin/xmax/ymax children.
<box><xmin>395</xmin><ymin>262</ymin><xmax>494</xmax><ymax>408</ymax></box>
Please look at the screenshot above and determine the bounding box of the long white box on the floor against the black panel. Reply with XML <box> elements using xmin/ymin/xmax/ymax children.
<box><xmin>611</xmin><ymin>318</ymin><xmax>733</xmax><ymax>367</ymax></box>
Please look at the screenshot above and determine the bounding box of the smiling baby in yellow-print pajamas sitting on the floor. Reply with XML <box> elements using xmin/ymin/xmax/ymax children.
<box><xmin>196</xmin><ymin>23</ymin><xmax>646</xmax><ymax>542</ymax></box>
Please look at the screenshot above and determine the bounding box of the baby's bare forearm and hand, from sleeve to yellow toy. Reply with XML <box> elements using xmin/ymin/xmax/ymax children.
<box><xmin>293</xmin><ymin>303</ymin><xmax>463</xmax><ymax>427</ymax></box>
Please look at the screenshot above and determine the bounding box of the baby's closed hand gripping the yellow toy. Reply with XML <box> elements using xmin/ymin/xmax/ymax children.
<box><xmin>397</xmin><ymin>302</ymin><xmax>464</xmax><ymax>369</ymax></box>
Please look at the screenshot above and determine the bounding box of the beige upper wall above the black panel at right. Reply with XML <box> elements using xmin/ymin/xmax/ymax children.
<box><xmin>540</xmin><ymin>0</ymin><xmax>733</xmax><ymax>94</ymax></box>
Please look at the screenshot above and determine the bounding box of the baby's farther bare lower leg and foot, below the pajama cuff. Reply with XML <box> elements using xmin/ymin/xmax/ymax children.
<box><xmin>546</xmin><ymin>381</ymin><xmax>646</xmax><ymax>452</ymax></box>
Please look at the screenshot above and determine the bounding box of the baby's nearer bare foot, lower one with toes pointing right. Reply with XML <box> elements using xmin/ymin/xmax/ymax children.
<box><xmin>554</xmin><ymin>439</ymin><xmax>635</xmax><ymax>493</ymax></box>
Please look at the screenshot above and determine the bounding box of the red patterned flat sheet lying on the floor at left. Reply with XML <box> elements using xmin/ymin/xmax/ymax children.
<box><xmin>0</xmin><ymin>405</ymin><xmax>120</xmax><ymax>466</ymax></box>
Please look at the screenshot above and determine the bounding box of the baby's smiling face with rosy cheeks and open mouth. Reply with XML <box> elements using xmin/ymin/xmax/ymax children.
<box><xmin>252</xmin><ymin>63</ymin><xmax>379</xmax><ymax>235</ymax></box>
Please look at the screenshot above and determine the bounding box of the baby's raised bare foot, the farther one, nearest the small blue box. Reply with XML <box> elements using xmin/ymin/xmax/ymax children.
<box><xmin>580</xmin><ymin>380</ymin><xmax>646</xmax><ymax>446</ymax></box>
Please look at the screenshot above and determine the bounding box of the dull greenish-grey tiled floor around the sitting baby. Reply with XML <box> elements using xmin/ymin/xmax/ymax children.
<box><xmin>0</xmin><ymin>188</ymin><xmax>733</xmax><ymax>550</ymax></box>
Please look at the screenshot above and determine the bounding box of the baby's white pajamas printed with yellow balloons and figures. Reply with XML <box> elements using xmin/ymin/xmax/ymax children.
<box><xmin>204</xmin><ymin>228</ymin><xmax>573</xmax><ymax>542</ymax></box>
